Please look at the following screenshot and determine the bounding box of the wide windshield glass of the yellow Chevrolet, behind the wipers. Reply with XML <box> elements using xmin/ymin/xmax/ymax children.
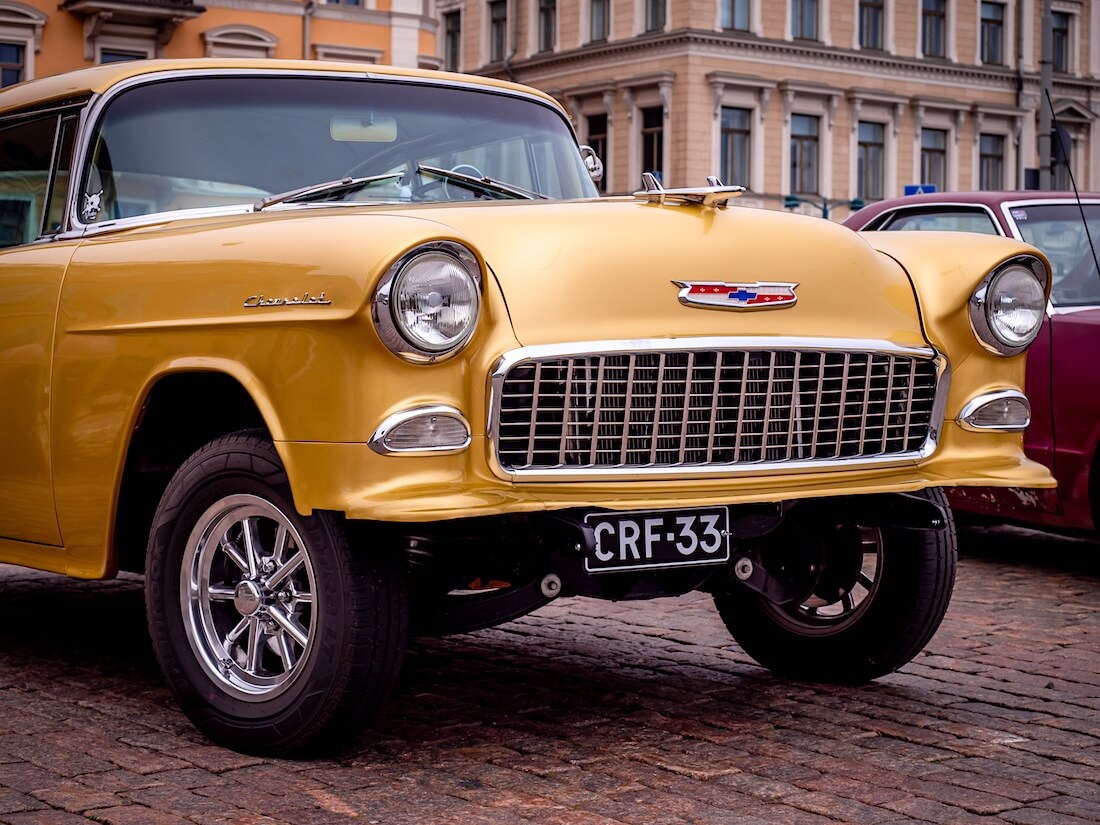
<box><xmin>79</xmin><ymin>76</ymin><xmax>596</xmax><ymax>223</ymax></box>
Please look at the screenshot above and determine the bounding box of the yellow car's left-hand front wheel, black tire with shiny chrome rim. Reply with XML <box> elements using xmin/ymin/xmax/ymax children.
<box><xmin>145</xmin><ymin>431</ymin><xmax>408</xmax><ymax>755</ymax></box>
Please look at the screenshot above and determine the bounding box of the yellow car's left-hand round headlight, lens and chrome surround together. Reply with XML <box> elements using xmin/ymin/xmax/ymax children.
<box><xmin>374</xmin><ymin>242</ymin><xmax>481</xmax><ymax>363</ymax></box>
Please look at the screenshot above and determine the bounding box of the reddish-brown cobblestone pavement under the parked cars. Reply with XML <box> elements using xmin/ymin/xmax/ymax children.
<box><xmin>0</xmin><ymin>529</ymin><xmax>1100</xmax><ymax>825</ymax></box>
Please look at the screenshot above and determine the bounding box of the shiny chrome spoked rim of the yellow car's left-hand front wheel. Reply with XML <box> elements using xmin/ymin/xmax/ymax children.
<box><xmin>179</xmin><ymin>495</ymin><xmax>317</xmax><ymax>702</ymax></box>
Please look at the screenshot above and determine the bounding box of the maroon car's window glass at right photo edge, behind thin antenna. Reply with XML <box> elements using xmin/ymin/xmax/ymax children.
<box><xmin>1009</xmin><ymin>204</ymin><xmax>1100</xmax><ymax>307</ymax></box>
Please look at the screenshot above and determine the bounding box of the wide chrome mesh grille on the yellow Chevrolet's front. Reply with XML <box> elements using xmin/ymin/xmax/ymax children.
<box><xmin>493</xmin><ymin>349</ymin><xmax>937</xmax><ymax>473</ymax></box>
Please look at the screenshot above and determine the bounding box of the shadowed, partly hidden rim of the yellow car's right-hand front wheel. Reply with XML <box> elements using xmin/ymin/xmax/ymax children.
<box><xmin>763</xmin><ymin>527</ymin><xmax>882</xmax><ymax>636</ymax></box>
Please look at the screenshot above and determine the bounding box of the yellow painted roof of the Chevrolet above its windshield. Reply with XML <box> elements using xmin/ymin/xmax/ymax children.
<box><xmin>0</xmin><ymin>57</ymin><xmax>560</xmax><ymax>116</ymax></box>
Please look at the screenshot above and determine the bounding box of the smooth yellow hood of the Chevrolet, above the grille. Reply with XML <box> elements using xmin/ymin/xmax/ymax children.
<box><xmin>396</xmin><ymin>199</ymin><xmax>927</xmax><ymax>347</ymax></box>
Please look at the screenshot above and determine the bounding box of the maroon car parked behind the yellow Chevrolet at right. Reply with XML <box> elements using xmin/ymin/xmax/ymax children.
<box><xmin>845</xmin><ymin>191</ymin><xmax>1100</xmax><ymax>530</ymax></box>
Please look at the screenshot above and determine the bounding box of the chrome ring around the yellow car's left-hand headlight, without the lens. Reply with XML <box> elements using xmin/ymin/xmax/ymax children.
<box><xmin>371</xmin><ymin>241</ymin><xmax>484</xmax><ymax>364</ymax></box>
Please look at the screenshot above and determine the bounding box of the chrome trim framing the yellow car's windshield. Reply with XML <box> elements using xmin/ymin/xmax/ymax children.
<box><xmin>66</xmin><ymin>67</ymin><xmax>580</xmax><ymax>238</ymax></box>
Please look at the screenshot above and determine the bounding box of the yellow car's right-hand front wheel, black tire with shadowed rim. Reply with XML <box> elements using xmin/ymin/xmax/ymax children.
<box><xmin>714</xmin><ymin>490</ymin><xmax>958</xmax><ymax>684</ymax></box>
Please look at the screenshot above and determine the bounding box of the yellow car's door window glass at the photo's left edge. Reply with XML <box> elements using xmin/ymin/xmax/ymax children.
<box><xmin>0</xmin><ymin>114</ymin><xmax>64</xmax><ymax>248</ymax></box>
